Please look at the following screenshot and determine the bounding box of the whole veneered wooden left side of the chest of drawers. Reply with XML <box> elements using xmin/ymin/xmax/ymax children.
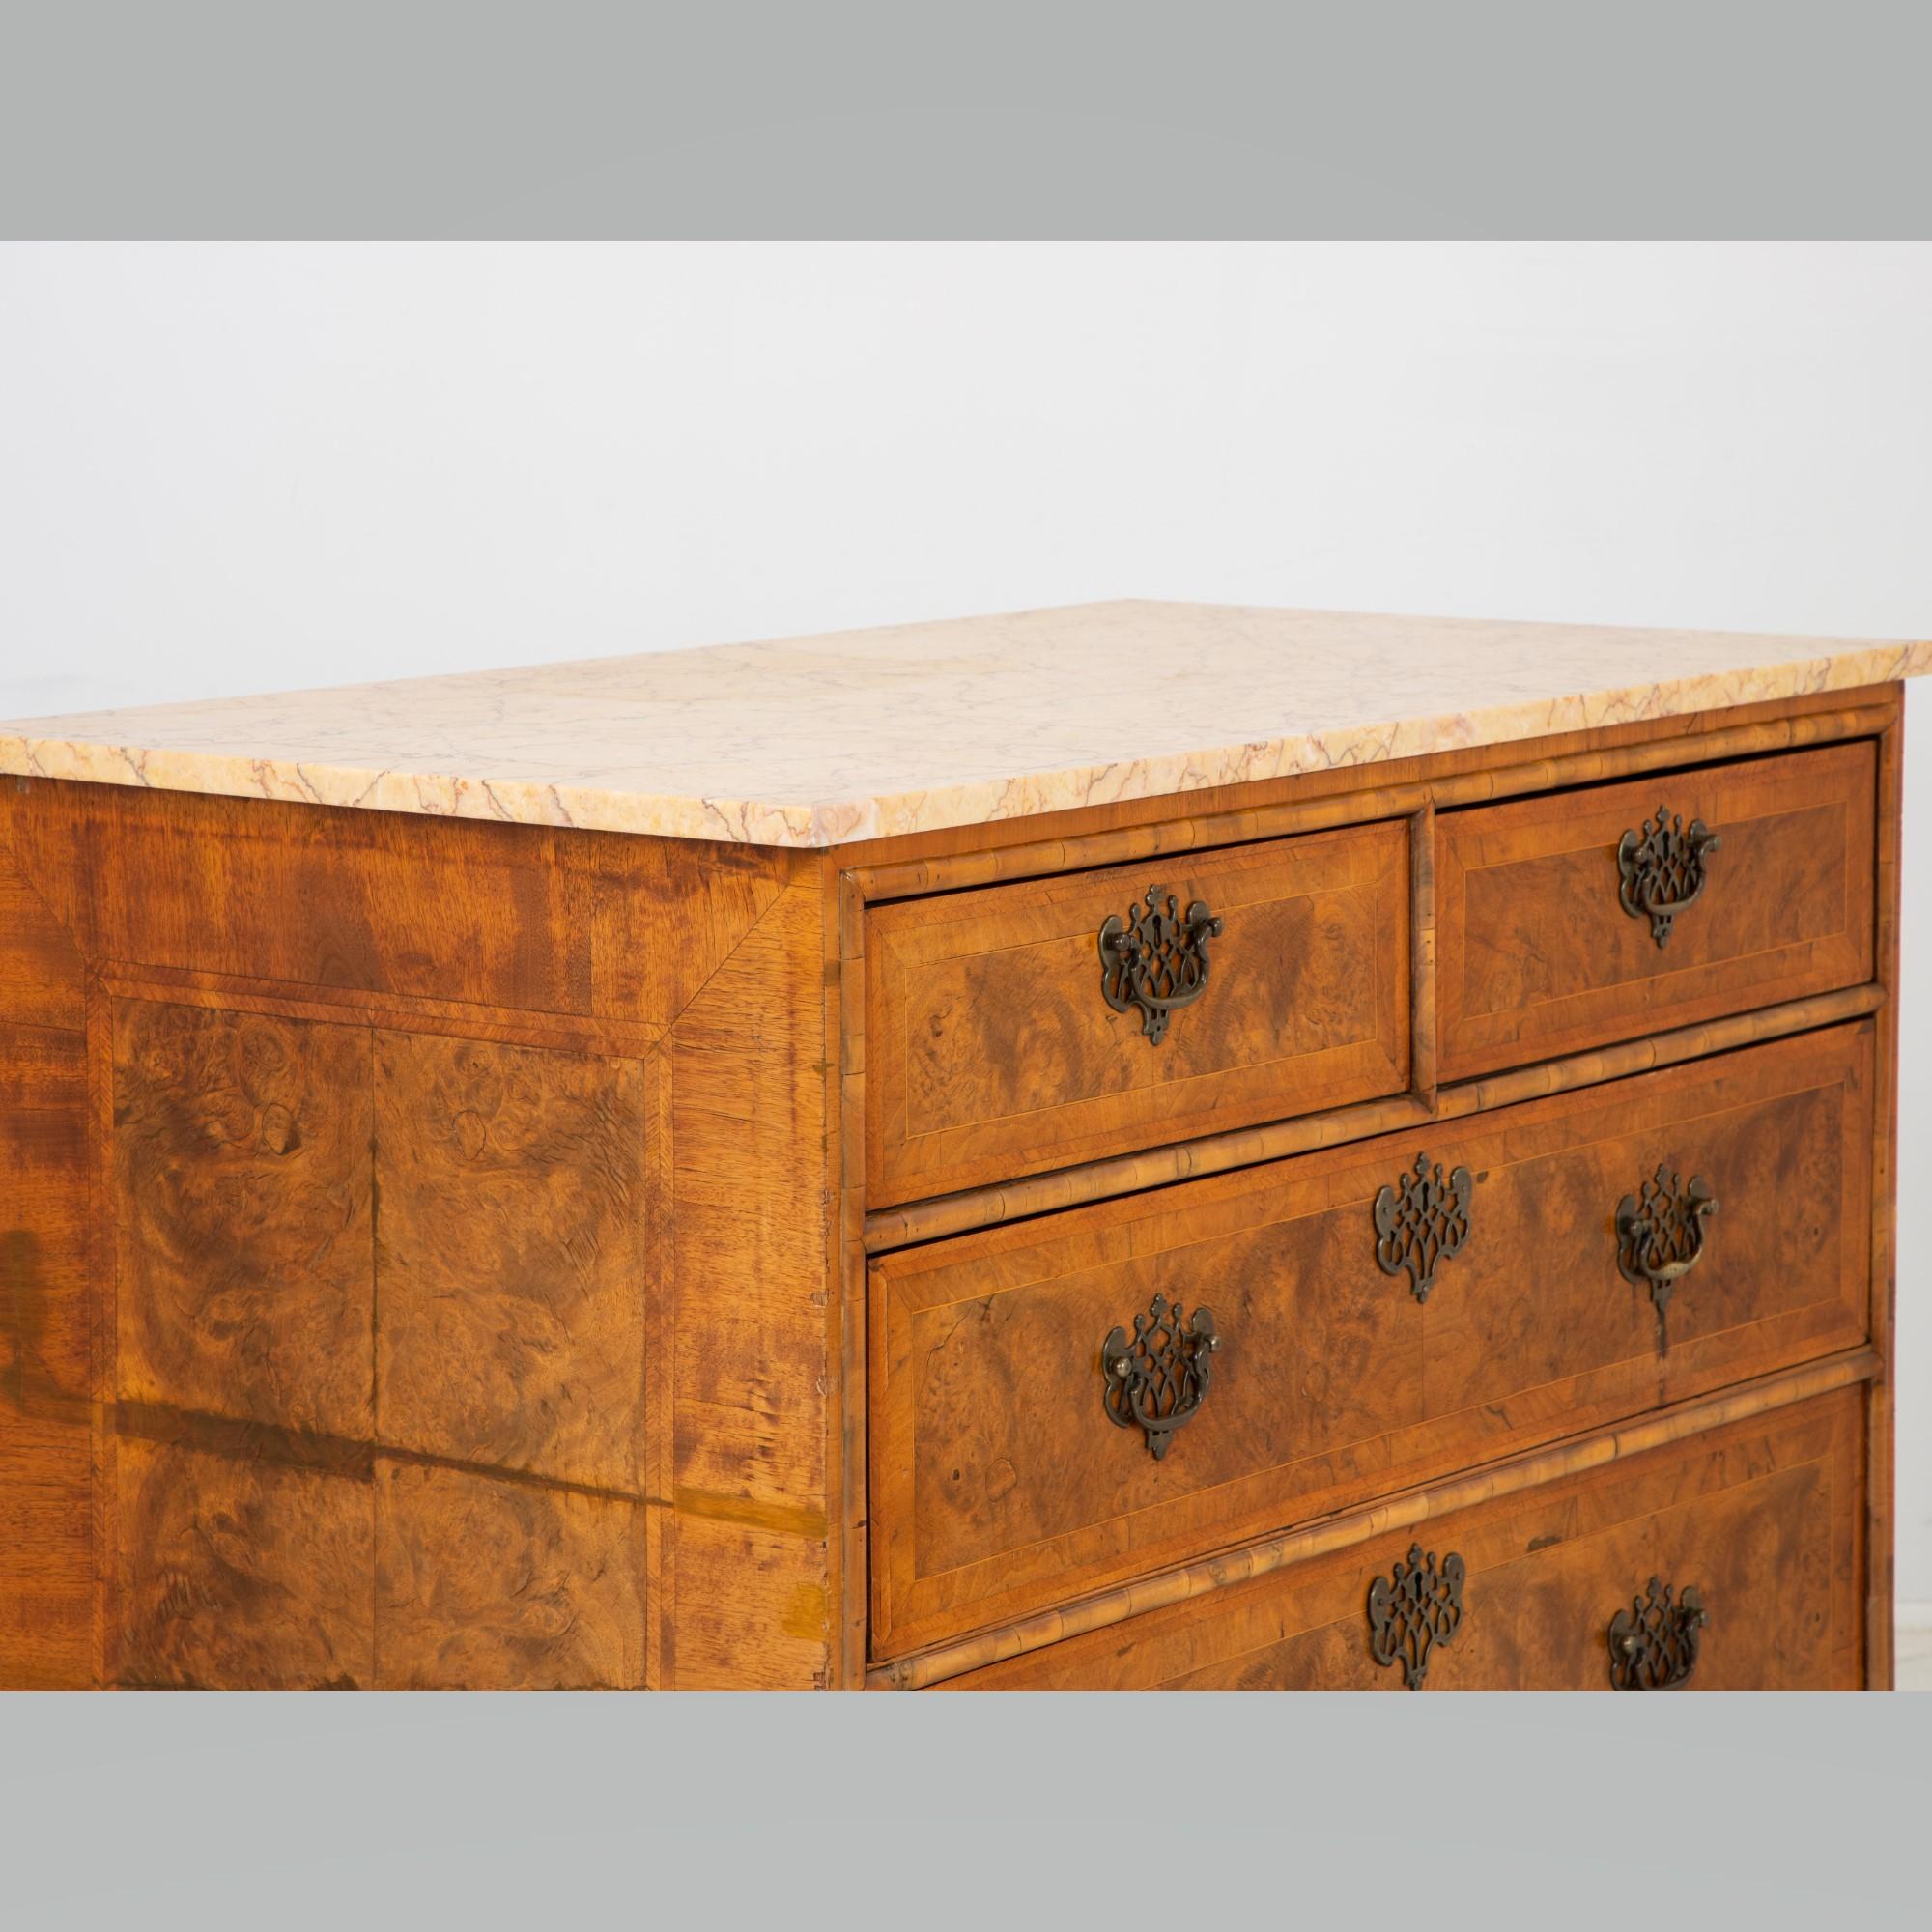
<box><xmin>0</xmin><ymin>781</ymin><xmax>844</xmax><ymax>1687</ymax></box>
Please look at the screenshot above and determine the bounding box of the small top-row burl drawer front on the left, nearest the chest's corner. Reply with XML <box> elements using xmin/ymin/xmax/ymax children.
<box><xmin>866</xmin><ymin>819</ymin><xmax>1408</xmax><ymax>1208</ymax></box>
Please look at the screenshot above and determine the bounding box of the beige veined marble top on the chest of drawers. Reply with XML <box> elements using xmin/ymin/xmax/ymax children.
<box><xmin>0</xmin><ymin>603</ymin><xmax>1932</xmax><ymax>846</ymax></box>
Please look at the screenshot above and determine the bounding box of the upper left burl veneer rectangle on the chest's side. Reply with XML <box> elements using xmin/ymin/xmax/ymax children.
<box><xmin>114</xmin><ymin>1001</ymin><xmax>373</xmax><ymax>1435</ymax></box>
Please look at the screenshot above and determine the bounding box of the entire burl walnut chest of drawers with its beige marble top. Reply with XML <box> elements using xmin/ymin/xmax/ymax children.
<box><xmin>0</xmin><ymin>605</ymin><xmax>1932</xmax><ymax>1690</ymax></box>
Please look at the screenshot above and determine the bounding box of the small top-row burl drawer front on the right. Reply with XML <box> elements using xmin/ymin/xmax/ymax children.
<box><xmin>1435</xmin><ymin>742</ymin><xmax>1878</xmax><ymax>1080</ymax></box>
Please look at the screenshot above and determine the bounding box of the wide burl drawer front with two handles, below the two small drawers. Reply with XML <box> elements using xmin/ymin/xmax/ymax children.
<box><xmin>871</xmin><ymin>1022</ymin><xmax>1872</xmax><ymax>1658</ymax></box>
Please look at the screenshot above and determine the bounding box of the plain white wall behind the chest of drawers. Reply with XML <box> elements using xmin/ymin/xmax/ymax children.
<box><xmin>0</xmin><ymin>243</ymin><xmax>1932</xmax><ymax>1621</ymax></box>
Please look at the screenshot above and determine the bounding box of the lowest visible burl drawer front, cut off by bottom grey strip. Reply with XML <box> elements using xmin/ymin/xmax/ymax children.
<box><xmin>939</xmin><ymin>1389</ymin><xmax>1864</xmax><ymax>1690</ymax></box>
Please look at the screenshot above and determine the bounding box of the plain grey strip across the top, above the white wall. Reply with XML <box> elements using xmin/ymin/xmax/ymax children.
<box><xmin>0</xmin><ymin>0</ymin><xmax>1932</xmax><ymax>240</ymax></box>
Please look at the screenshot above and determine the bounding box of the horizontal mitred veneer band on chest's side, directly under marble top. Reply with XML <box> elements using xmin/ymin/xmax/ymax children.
<box><xmin>8</xmin><ymin>781</ymin><xmax>792</xmax><ymax>1024</ymax></box>
